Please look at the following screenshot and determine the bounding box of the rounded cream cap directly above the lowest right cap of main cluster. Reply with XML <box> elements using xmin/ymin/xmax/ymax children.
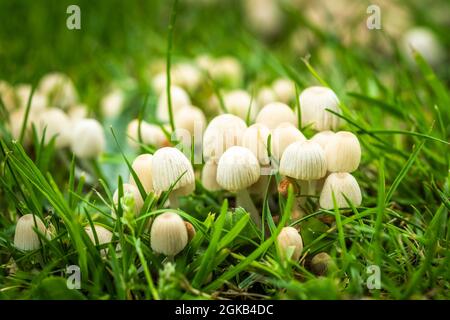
<box><xmin>325</xmin><ymin>131</ymin><xmax>361</xmax><ymax>172</ymax></box>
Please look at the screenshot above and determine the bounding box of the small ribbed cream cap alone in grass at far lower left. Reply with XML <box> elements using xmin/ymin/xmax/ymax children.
<box><xmin>14</xmin><ymin>214</ymin><xmax>50</xmax><ymax>251</ymax></box>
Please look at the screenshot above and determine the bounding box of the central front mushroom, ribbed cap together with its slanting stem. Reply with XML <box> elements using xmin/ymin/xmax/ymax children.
<box><xmin>217</xmin><ymin>146</ymin><xmax>261</xmax><ymax>227</ymax></box>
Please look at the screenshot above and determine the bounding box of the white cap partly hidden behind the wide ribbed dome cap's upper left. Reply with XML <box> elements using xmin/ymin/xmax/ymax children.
<box><xmin>270</xmin><ymin>122</ymin><xmax>306</xmax><ymax>161</ymax></box>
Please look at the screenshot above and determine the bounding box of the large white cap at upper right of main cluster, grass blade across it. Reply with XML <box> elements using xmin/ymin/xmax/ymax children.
<box><xmin>299</xmin><ymin>86</ymin><xmax>341</xmax><ymax>131</ymax></box>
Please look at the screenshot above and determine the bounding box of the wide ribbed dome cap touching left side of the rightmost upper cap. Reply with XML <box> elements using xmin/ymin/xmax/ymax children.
<box><xmin>280</xmin><ymin>140</ymin><xmax>327</xmax><ymax>180</ymax></box>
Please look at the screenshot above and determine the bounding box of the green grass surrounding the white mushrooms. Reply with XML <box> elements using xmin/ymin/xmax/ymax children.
<box><xmin>0</xmin><ymin>1</ymin><xmax>450</xmax><ymax>299</ymax></box>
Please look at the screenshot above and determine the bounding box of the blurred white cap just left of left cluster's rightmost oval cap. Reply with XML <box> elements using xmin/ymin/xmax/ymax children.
<box><xmin>36</xmin><ymin>108</ymin><xmax>72</xmax><ymax>148</ymax></box>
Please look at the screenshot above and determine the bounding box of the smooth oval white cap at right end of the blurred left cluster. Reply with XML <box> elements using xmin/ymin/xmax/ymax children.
<box><xmin>71</xmin><ymin>119</ymin><xmax>106</xmax><ymax>159</ymax></box>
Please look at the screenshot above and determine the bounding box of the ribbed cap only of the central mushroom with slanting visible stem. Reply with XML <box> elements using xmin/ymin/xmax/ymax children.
<box><xmin>217</xmin><ymin>146</ymin><xmax>260</xmax><ymax>191</ymax></box>
